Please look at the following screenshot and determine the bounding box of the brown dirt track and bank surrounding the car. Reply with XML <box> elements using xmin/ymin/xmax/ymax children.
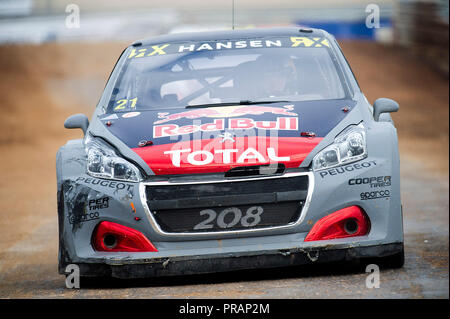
<box><xmin>0</xmin><ymin>42</ymin><xmax>449</xmax><ymax>298</ymax></box>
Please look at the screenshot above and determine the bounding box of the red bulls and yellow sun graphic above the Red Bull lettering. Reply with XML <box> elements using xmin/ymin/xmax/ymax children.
<box><xmin>154</xmin><ymin>105</ymin><xmax>298</xmax><ymax>124</ymax></box>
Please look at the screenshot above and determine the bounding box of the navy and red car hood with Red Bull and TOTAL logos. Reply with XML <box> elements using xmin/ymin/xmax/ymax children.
<box><xmin>99</xmin><ymin>99</ymin><xmax>356</xmax><ymax>175</ymax></box>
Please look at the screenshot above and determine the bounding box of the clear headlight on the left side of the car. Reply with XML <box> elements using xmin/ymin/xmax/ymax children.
<box><xmin>84</xmin><ymin>136</ymin><xmax>141</xmax><ymax>182</ymax></box>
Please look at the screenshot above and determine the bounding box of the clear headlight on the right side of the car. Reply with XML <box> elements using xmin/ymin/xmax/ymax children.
<box><xmin>313</xmin><ymin>123</ymin><xmax>367</xmax><ymax>171</ymax></box>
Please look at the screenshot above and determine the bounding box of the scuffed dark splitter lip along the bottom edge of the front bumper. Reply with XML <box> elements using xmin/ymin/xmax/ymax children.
<box><xmin>74</xmin><ymin>243</ymin><xmax>403</xmax><ymax>279</ymax></box>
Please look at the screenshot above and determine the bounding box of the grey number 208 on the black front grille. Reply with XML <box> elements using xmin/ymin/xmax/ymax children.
<box><xmin>194</xmin><ymin>206</ymin><xmax>264</xmax><ymax>229</ymax></box>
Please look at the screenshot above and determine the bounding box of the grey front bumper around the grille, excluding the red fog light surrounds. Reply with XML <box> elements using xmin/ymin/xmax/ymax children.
<box><xmin>58</xmin><ymin>152</ymin><xmax>403</xmax><ymax>278</ymax></box>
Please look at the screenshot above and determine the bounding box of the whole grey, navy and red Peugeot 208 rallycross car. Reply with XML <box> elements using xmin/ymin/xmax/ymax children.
<box><xmin>56</xmin><ymin>28</ymin><xmax>403</xmax><ymax>278</ymax></box>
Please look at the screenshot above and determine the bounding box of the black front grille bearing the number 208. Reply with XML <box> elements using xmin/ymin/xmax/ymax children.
<box><xmin>145</xmin><ymin>175</ymin><xmax>309</xmax><ymax>233</ymax></box>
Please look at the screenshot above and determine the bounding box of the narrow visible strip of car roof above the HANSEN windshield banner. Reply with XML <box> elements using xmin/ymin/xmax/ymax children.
<box><xmin>132</xmin><ymin>26</ymin><xmax>330</xmax><ymax>46</ymax></box>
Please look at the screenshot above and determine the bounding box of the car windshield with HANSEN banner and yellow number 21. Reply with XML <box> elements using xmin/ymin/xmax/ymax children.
<box><xmin>107</xmin><ymin>37</ymin><xmax>346</xmax><ymax>113</ymax></box>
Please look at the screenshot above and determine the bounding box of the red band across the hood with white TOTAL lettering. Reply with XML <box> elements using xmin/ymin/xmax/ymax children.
<box><xmin>133</xmin><ymin>137</ymin><xmax>322</xmax><ymax>175</ymax></box>
